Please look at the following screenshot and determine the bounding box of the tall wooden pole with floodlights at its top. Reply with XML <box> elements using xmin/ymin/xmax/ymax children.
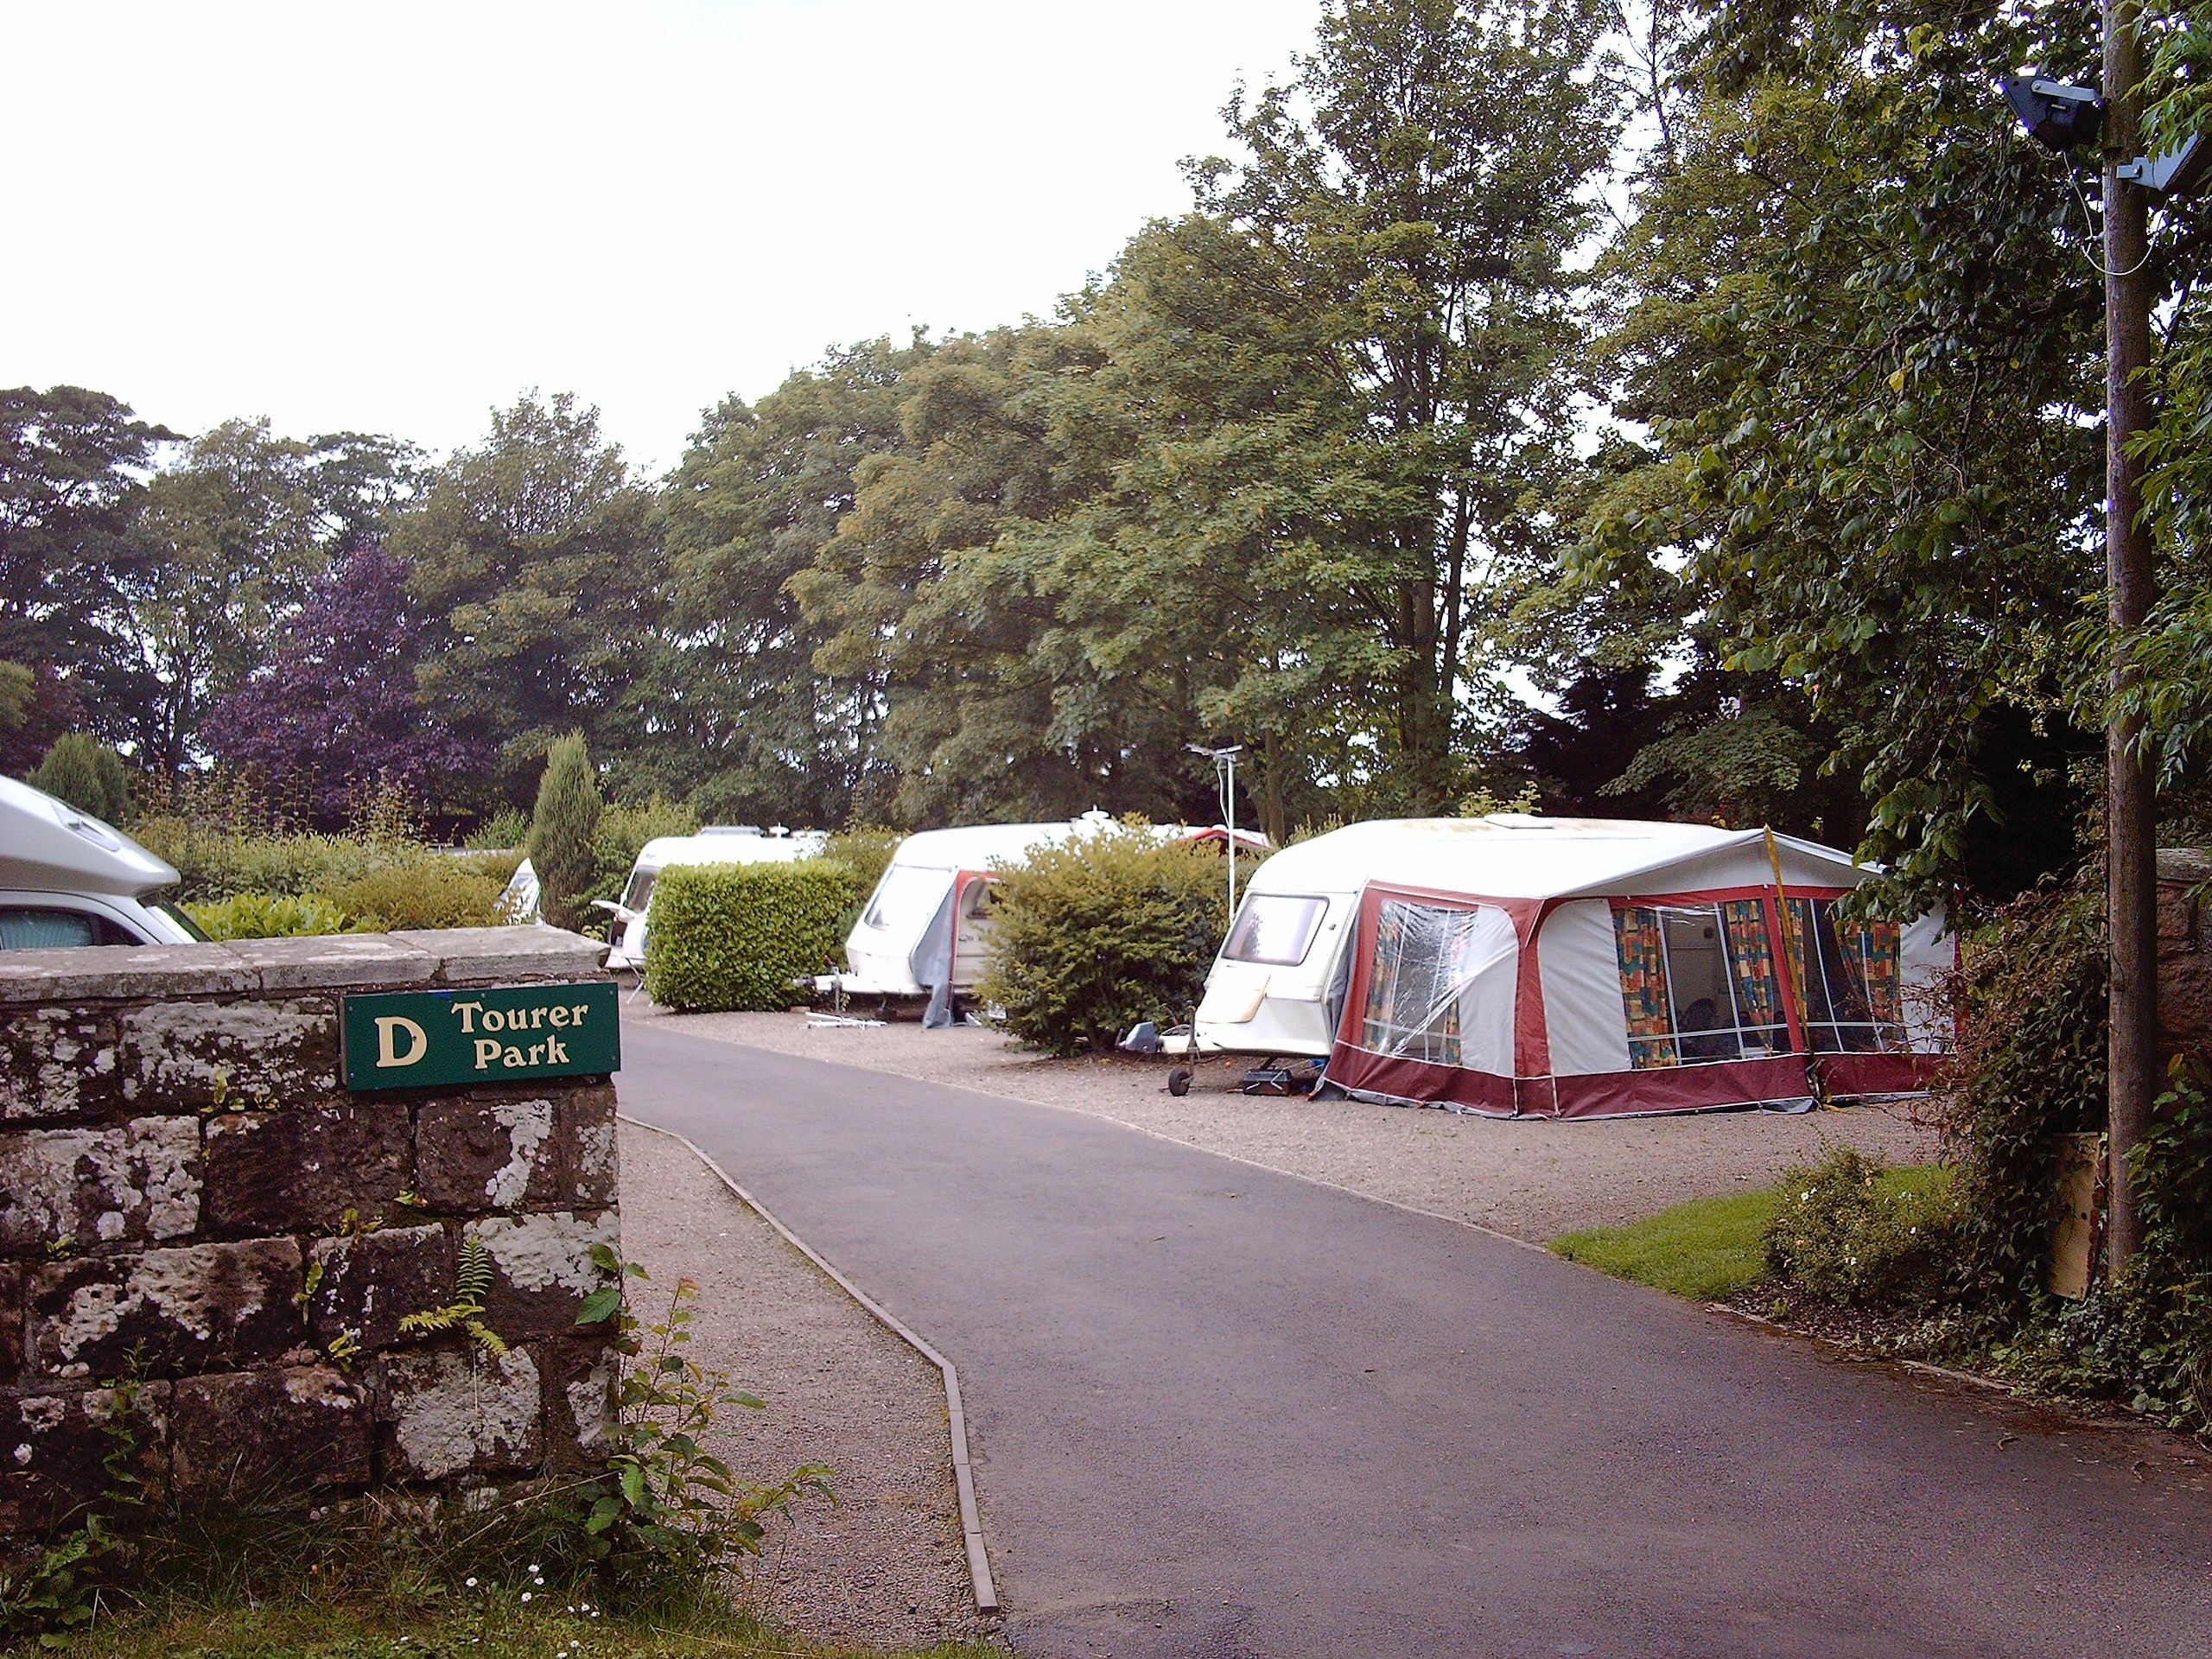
<box><xmin>2104</xmin><ymin>0</ymin><xmax>2159</xmax><ymax>1274</ymax></box>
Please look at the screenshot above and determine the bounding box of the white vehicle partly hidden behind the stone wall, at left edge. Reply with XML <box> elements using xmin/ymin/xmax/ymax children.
<box><xmin>0</xmin><ymin>779</ymin><xmax>206</xmax><ymax>951</ymax></box>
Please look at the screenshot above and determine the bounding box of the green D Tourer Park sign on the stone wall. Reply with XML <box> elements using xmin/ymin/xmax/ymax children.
<box><xmin>340</xmin><ymin>980</ymin><xmax>621</xmax><ymax>1089</ymax></box>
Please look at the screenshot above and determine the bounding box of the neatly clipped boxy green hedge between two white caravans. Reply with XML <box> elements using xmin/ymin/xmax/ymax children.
<box><xmin>646</xmin><ymin>858</ymin><xmax>858</xmax><ymax>1008</ymax></box>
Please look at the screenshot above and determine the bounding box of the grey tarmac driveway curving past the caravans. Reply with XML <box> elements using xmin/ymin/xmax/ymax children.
<box><xmin>621</xmin><ymin>1027</ymin><xmax>2212</xmax><ymax>1659</ymax></box>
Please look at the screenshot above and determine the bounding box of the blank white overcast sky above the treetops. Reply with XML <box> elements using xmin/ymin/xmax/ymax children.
<box><xmin>0</xmin><ymin>0</ymin><xmax>1319</xmax><ymax>467</ymax></box>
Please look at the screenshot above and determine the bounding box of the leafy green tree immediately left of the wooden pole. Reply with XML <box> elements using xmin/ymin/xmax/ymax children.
<box><xmin>1586</xmin><ymin>0</ymin><xmax>2104</xmax><ymax>898</ymax></box>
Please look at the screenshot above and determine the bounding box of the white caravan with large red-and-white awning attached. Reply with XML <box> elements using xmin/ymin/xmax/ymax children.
<box><xmin>1192</xmin><ymin>814</ymin><xmax>1953</xmax><ymax>1117</ymax></box>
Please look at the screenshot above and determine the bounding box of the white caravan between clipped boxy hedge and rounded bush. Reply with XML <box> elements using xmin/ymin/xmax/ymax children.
<box><xmin>814</xmin><ymin>812</ymin><xmax>1268</xmax><ymax>1000</ymax></box>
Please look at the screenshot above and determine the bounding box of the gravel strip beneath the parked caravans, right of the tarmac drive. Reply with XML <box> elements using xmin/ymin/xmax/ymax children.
<box><xmin>628</xmin><ymin>1002</ymin><xmax>1936</xmax><ymax>1241</ymax></box>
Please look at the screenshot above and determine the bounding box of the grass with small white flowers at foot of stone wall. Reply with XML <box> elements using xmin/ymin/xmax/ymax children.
<box><xmin>39</xmin><ymin>1591</ymin><xmax>1002</xmax><ymax>1659</ymax></box>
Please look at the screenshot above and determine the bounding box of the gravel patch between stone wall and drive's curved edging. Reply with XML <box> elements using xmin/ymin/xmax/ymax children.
<box><xmin>621</xmin><ymin>1123</ymin><xmax>982</xmax><ymax>1648</ymax></box>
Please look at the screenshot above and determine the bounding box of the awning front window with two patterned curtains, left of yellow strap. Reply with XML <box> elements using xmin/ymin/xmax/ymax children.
<box><xmin>1612</xmin><ymin>898</ymin><xmax>1789</xmax><ymax>1066</ymax></box>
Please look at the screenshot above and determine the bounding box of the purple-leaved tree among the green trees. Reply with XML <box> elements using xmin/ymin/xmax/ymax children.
<box><xmin>201</xmin><ymin>546</ymin><xmax>491</xmax><ymax>825</ymax></box>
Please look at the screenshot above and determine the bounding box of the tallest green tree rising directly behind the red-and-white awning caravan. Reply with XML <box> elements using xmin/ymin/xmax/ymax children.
<box><xmin>1197</xmin><ymin>0</ymin><xmax>1612</xmax><ymax>812</ymax></box>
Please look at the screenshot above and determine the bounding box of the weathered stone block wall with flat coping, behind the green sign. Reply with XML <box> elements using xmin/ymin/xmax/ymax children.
<box><xmin>0</xmin><ymin>927</ymin><xmax>620</xmax><ymax>1533</ymax></box>
